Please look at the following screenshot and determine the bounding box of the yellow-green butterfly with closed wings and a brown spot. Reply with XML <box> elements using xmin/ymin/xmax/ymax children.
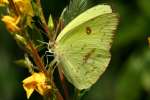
<box><xmin>52</xmin><ymin>5</ymin><xmax>118</xmax><ymax>90</ymax></box>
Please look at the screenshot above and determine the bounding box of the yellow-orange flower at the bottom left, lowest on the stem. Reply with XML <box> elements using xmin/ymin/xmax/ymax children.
<box><xmin>23</xmin><ymin>72</ymin><xmax>51</xmax><ymax>99</ymax></box>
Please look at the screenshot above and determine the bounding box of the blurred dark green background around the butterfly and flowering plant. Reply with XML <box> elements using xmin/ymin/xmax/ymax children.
<box><xmin>0</xmin><ymin>0</ymin><xmax>150</xmax><ymax>100</ymax></box>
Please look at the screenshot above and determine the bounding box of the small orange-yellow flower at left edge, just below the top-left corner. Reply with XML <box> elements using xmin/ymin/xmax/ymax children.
<box><xmin>2</xmin><ymin>16</ymin><xmax>20</xmax><ymax>32</ymax></box>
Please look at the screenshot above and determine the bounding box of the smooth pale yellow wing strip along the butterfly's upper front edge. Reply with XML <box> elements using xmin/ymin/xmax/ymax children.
<box><xmin>56</xmin><ymin>5</ymin><xmax>112</xmax><ymax>41</ymax></box>
